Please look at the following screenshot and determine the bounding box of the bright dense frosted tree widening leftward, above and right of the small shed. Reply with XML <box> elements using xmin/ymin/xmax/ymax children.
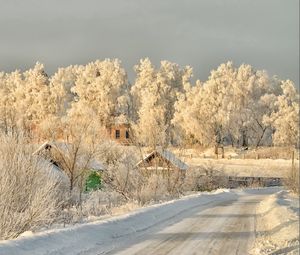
<box><xmin>173</xmin><ymin>62</ymin><xmax>235</xmax><ymax>147</ymax></box>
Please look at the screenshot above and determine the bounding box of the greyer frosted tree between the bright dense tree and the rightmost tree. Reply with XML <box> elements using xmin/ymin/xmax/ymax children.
<box><xmin>226</xmin><ymin>64</ymin><xmax>278</xmax><ymax>146</ymax></box>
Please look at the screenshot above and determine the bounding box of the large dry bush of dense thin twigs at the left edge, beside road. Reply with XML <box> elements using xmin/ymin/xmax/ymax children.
<box><xmin>0</xmin><ymin>135</ymin><xmax>62</xmax><ymax>239</ymax></box>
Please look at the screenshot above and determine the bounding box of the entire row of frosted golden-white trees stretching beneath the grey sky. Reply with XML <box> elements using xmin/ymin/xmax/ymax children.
<box><xmin>0</xmin><ymin>58</ymin><xmax>299</xmax><ymax>146</ymax></box>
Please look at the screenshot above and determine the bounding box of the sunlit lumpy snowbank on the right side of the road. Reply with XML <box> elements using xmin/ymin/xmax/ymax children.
<box><xmin>251</xmin><ymin>191</ymin><xmax>299</xmax><ymax>255</ymax></box>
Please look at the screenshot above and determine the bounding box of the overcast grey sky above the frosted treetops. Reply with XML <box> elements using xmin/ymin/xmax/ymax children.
<box><xmin>0</xmin><ymin>0</ymin><xmax>299</xmax><ymax>86</ymax></box>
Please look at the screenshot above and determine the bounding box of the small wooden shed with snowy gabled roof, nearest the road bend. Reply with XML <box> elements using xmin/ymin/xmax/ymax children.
<box><xmin>137</xmin><ymin>148</ymin><xmax>189</xmax><ymax>174</ymax></box>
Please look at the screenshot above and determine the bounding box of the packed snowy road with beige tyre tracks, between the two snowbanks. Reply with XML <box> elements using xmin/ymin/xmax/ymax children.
<box><xmin>109</xmin><ymin>187</ymin><xmax>280</xmax><ymax>255</ymax></box>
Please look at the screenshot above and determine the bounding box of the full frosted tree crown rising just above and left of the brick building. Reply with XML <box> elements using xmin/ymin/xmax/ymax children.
<box><xmin>71</xmin><ymin>59</ymin><xmax>128</xmax><ymax>126</ymax></box>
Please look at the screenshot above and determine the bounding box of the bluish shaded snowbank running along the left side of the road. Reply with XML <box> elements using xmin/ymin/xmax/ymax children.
<box><xmin>0</xmin><ymin>190</ymin><xmax>237</xmax><ymax>255</ymax></box>
